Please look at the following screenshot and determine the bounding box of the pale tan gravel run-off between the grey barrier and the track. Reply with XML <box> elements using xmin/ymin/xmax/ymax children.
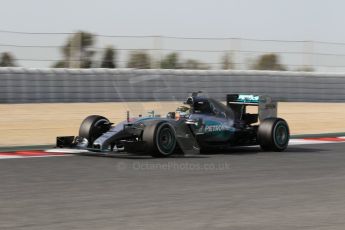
<box><xmin>0</xmin><ymin>102</ymin><xmax>345</xmax><ymax>146</ymax></box>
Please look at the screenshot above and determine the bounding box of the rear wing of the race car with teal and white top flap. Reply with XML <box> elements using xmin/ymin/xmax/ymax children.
<box><xmin>226</xmin><ymin>94</ymin><xmax>278</xmax><ymax>121</ymax></box>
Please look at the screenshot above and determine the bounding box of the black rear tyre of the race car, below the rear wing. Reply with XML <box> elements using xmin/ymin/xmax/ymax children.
<box><xmin>258</xmin><ymin>117</ymin><xmax>290</xmax><ymax>152</ymax></box>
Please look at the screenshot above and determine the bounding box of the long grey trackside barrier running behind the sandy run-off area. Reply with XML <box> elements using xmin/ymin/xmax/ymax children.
<box><xmin>0</xmin><ymin>68</ymin><xmax>345</xmax><ymax>104</ymax></box>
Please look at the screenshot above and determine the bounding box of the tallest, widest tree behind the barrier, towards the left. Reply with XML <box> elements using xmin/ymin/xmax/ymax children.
<box><xmin>53</xmin><ymin>31</ymin><xmax>95</xmax><ymax>68</ymax></box>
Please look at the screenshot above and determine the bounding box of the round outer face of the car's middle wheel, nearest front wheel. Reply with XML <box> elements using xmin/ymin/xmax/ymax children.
<box><xmin>157</xmin><ymin>126</ymin><xmax>176</xmax><ymax>155</ymax></box>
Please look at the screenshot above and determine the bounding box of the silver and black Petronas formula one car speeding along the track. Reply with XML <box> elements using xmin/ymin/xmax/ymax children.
<box><xmin>56</xmin><ymin>92</ymin><xmax>290</xmax><ymax>157</ymax></box>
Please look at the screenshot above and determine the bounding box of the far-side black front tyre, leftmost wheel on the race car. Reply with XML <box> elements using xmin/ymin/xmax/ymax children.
<box><xmin>79</xmin><ymin>115</ymin><xmax>111</xmax><ymax>145</ymax></box>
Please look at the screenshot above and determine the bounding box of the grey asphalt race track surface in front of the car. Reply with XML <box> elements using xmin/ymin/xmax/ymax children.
<box><xmin>0</xmin><ymin>143</ymin><xmax>345</xmax><ymax>230</ymax></box>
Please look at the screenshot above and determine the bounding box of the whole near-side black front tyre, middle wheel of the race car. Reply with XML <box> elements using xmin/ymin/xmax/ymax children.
<box><xmin>143</xmin><ymin>121</ymin><xmax>176</xmax><ymax>157</ymax></box>
